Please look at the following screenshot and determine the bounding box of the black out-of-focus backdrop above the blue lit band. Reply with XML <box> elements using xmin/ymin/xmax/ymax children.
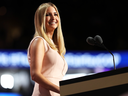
<box><xmin>0</xmin><ymin>0</ymin><xmax>128</xmax><ymax>50</ymax></box>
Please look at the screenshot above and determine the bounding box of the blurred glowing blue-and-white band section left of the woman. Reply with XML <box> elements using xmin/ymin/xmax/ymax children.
<box><xmin>0</xmin><ymin>51</ymin><xmax>29</xmax><ymax>68</ymax></box>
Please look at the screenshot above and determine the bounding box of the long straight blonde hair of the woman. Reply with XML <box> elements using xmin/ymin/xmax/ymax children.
<box><xmin>34</xmin><ymin>2</ymin><xmax>66</xmax><ymax>57</ymax></box>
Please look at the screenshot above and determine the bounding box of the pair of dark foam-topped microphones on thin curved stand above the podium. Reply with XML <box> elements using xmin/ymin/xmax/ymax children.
<box><xmin>86</xmin><ymin>35</ymin><xmax>116</xmax><ymax>70</ymax></box>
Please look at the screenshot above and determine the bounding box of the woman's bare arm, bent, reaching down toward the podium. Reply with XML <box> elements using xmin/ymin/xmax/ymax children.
<box><xmin>30</xmin><ymin>38</ymin><xmax>60</xmax><ymax>93</ymax></box>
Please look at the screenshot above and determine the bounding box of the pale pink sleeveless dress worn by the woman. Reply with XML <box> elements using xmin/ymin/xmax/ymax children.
<box><xmin>27</xmin><ymin>36</ymin><xmax>68</xmax><ymax>96</ymax></box>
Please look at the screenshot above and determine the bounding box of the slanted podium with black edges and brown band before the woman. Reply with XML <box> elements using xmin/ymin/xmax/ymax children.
<box><xmin>60</xmin><ymin>67</ymin><xmax>128</xmax><ymax>96</ymax></box>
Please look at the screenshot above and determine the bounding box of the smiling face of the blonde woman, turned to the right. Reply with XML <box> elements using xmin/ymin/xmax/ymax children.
<box><xmin>45</xmin><ymin>6</ymin><xmax>59</xmax><ymax>31</ymax></box>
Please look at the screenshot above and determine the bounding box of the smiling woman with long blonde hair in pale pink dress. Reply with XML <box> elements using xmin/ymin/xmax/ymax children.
<box><xmin>28</xmin><ymin>3</ymin><xmax>67</xmax><ymax>96</ymax></box>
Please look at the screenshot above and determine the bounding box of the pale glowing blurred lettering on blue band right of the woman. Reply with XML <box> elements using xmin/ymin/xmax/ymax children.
<box><xmin>65</xmin><ymin>52</ymin><xmax>122</xmax><ymax>68</ymax></box>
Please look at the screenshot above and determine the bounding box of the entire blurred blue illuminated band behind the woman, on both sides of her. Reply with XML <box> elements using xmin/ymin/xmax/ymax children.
<box><xmin>0</xmin><ymin>50</ymin><xmax>128</xmax><ymax>69</ymax></box>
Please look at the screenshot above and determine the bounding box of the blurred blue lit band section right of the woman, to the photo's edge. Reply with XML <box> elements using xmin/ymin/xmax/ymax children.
<box><xmin>65</xmin><ymin>51</ymin><xmax>128</xmax><ymax>68</ymax></box>
